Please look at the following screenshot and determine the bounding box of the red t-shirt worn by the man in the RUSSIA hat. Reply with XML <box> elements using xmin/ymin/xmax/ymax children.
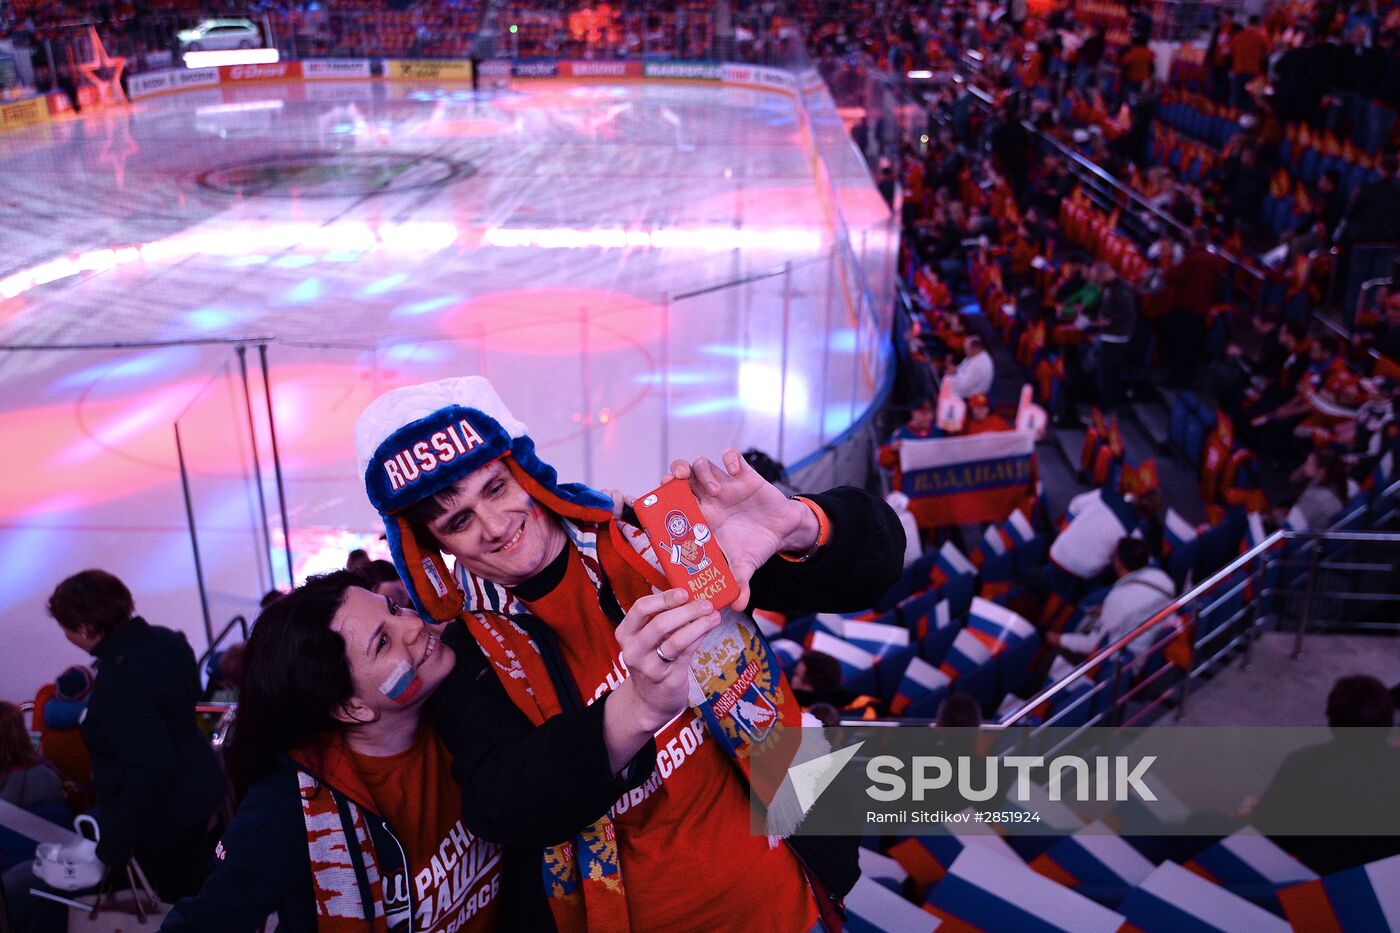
<box><xmin>526</xmin><ymin>545</ymin><xmax>818</xmax><ymax>933</ymax></box>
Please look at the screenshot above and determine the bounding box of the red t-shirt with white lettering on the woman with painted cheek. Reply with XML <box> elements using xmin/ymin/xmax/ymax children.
<box><xmin>350</xmin><ymin>726</ymin><xmax>501</xmax><ymax>933</ymax></box>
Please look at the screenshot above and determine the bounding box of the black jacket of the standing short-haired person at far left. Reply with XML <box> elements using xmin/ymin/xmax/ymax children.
<box><xmin>83</xmin><ymin>616</ymin><xmax>224</xmax><ymax>864</ymax></box>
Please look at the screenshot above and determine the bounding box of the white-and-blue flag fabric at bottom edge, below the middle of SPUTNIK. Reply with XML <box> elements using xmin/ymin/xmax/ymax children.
<box><xmin>924</xmin><ymin>846</ymin><xmax>1123</xmax><ymax>933</ymax></box>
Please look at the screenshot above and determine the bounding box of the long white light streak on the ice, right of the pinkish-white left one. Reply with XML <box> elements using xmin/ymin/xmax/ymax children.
<box><xmin>482</xmin><ymin>227</ymin><xmax>822</xmax><ymax>252</ymax></box>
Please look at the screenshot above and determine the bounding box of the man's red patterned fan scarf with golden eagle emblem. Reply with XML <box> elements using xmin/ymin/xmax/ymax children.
<box><xmin>456</xmin><ymin>457</ymin><xmax>822</xmax><ymax>933</ymax></box>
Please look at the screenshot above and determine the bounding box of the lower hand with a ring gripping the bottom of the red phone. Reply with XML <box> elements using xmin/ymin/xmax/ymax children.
<box><xmin>603</xmin><ymin>590</ymin><xmax>720</xmax><ymax>772</ymax></box>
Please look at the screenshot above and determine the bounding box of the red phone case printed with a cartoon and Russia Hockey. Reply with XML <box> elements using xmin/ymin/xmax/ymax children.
<box><xmin>633</xmin><ymin>481</ymin><xmax>739</xmax><ymax>609</ymax></box>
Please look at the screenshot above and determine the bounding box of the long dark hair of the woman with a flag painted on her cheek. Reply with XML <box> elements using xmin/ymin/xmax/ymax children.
<box><xmin>228</xmin><ymin>570</ymin><xmax>365</xmax><ymax>799</ymax></box>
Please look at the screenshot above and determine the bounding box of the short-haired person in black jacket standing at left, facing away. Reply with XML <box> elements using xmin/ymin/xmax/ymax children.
<box><xmin>49</xmin><ymin>570</ymin><xmax>224</xmax><ymax>901</ymax></box>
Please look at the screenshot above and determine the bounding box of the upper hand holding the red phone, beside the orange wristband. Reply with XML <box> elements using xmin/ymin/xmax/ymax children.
<box><xmin>661</xmin><ymin>448</ymin><xmax>820</xmax><ymax>612</ymax></box>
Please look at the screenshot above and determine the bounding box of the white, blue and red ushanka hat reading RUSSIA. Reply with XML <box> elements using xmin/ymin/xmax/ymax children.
<box><xmin>354</xmin><ymin>375</ymin><xmax>612</xmax><ymax>622</ymax></box>
